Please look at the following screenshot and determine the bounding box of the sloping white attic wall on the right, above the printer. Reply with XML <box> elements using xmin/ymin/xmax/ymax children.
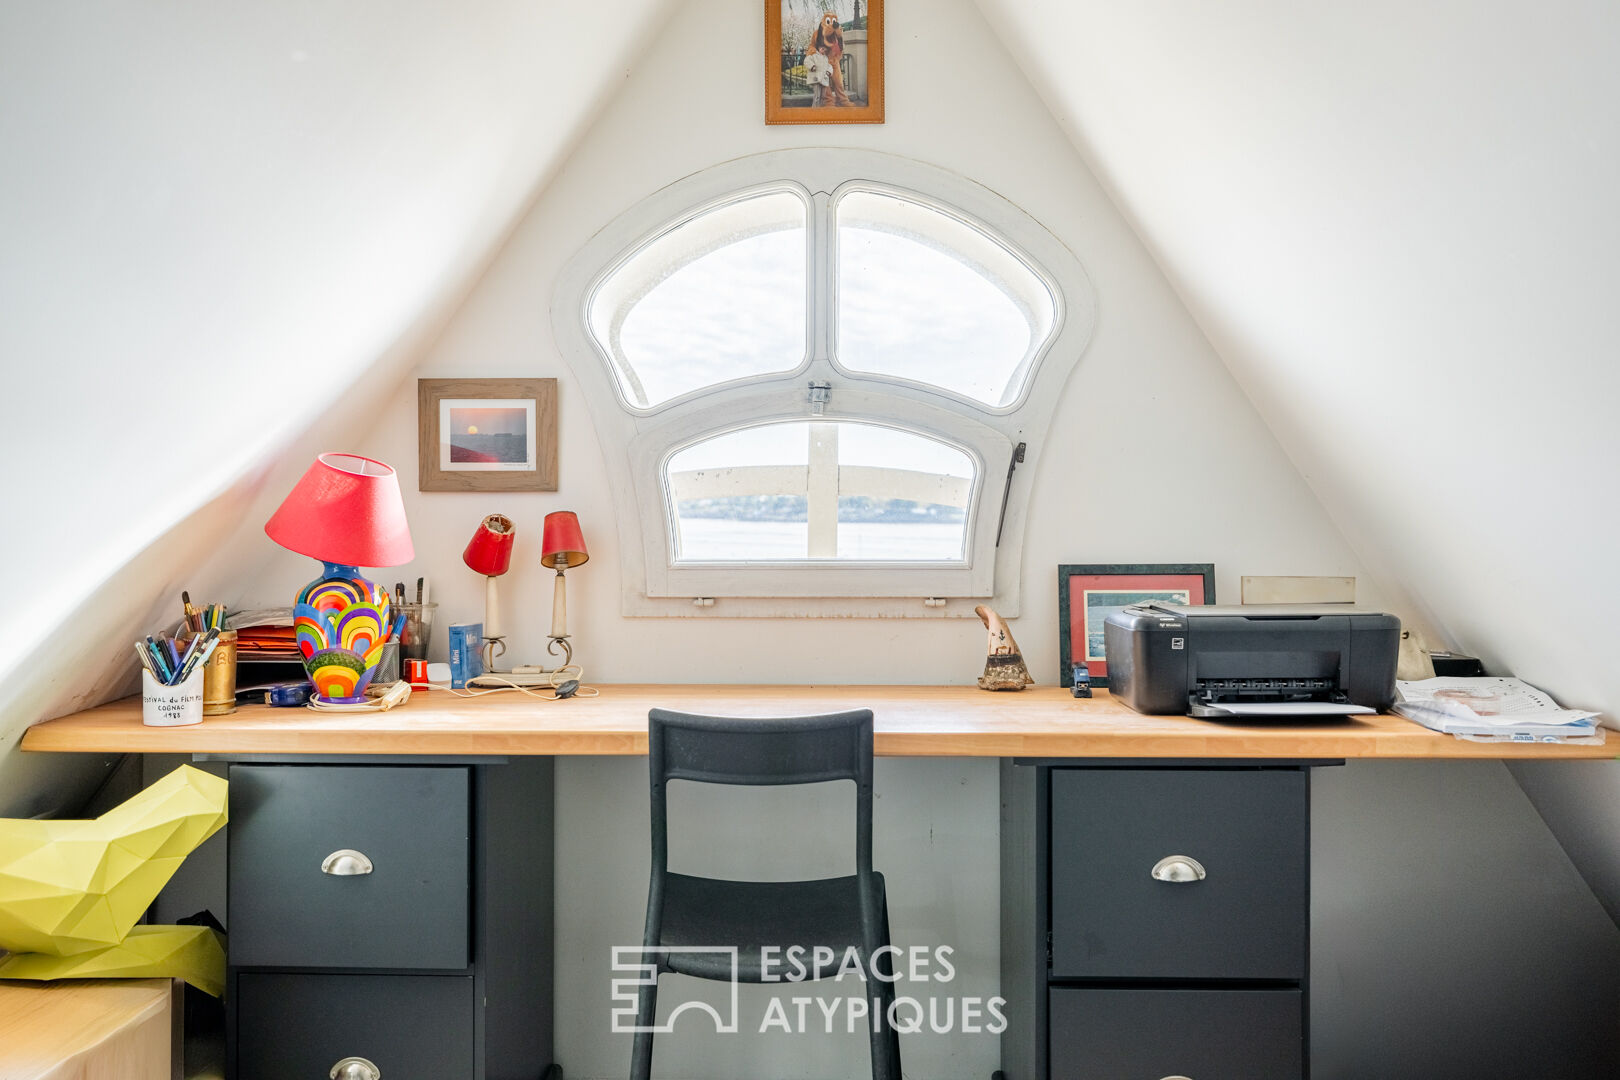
<box><xmin>978</xmin><ymin>0</ymin><xmax>1620</xmax><ymax>918</ymax></box>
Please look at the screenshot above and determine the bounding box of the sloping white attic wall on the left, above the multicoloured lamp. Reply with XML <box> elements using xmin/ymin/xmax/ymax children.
<box><xmin>0</xmin><ymin>0</ymin><xmax>671</xmax><ymax>813</ymax></box>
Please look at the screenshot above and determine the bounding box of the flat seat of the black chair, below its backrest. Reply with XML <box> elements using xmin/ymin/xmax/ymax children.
<box><xmin>659</xmin><ymin>873</ymin><xmax>889</xmax><ymax>983</ymax></box>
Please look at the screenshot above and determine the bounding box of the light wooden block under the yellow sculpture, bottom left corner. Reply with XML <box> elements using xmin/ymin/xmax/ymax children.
<box><xmin>0</xmin><ymin>978</ymin><xmax>183</xmax><ymax>1080</ymax></box>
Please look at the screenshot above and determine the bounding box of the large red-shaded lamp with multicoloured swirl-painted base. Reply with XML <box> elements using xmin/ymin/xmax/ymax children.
<box><xmin>264</xmin><ymin>453</ymin><xmax>416</xmax><ymax>703</ymax></box>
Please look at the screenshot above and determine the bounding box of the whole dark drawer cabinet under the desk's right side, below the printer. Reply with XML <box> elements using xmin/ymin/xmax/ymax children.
<box><xmin>1001</xmin><ymin>761</ymin><xmax>1330</xmax><ymax>1080</ymax></box>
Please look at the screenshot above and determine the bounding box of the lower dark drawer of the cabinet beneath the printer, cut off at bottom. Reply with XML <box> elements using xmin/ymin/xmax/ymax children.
<box><xmin>1051</xmin><ymin>989</ymin><xmax>1304</xmax><ymax>1080</ymax></box>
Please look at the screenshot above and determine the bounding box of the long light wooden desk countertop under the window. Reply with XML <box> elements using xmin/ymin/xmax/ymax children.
<box><xmin>23</xmin><ymin>685</ymin><xmax>1620</xmax><ymax>759</ymax></box>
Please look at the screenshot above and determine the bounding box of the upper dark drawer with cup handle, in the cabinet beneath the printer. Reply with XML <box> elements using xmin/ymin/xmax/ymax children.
<box><xmin>1051</xmin><ymin>769</ymin><xmax>1309</xmax><ymax>977</ymax></box>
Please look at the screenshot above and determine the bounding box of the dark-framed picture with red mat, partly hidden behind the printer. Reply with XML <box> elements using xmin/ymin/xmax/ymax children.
<box><xmin>1058</xmin><ymin>562</ymin><xmax>1215</xmax><ymax>687</ymax></box>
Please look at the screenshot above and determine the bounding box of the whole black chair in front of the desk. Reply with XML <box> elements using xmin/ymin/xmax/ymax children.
<box><xmin>630</xmin><ymin>709</ymin><xmax>901</xmax><ymax>1080</ymax></box>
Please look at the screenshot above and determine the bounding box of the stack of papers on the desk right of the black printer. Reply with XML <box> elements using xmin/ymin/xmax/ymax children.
<box><xmin>1395</xmin><ymin>677</ymin><xmax>1604</xmax><ymax>743</ymax></box>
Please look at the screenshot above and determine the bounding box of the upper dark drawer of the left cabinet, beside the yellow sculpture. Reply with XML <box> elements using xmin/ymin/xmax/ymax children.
<box><xmin>228</xmin><ymin>764</ymin><xmax>471</xmax><ymax>970</ymax></box>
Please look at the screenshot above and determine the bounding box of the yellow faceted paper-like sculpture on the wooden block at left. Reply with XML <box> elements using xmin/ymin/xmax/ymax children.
<box><xmin>0</xmin><ymin>766</ymin><xmax>225</xmax><ymax>993</ymax></box>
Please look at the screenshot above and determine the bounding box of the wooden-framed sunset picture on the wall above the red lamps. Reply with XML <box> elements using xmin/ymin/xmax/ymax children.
<box><xmin>416</xmin><ymin>379</ymin><xmax>557</xmax><ymax>491</ymax></box>
